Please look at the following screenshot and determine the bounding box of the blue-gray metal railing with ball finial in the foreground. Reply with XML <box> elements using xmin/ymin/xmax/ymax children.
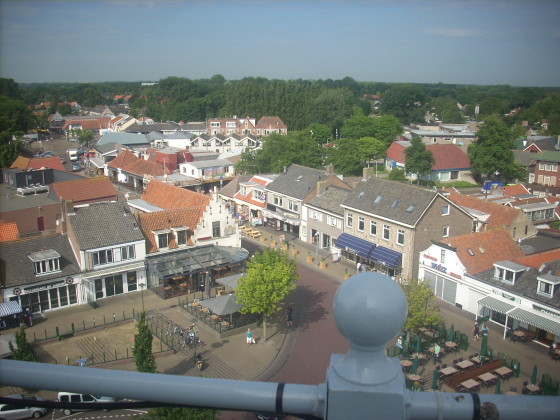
<box><xmin>0</xmin><ymin>272</ymin><xmax>560</xmax><ymax>420</ymax></box>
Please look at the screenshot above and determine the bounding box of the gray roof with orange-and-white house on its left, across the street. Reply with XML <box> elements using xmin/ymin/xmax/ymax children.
<box><xmin>266</xmin><ymin>164</ymin><xmax>329</xmax><ymax>200</ymax></box>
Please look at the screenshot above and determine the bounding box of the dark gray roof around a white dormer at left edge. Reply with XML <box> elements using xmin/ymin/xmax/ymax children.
<box><xmin>0</xmin><ymin>234</ymin><xmax>80</xmax><ymax>287</ymax></box>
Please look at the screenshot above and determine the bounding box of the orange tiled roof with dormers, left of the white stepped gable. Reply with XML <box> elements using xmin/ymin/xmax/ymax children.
<box><xmin>138</xmin><ymin>207</ymin><xmax>202</xmax><ymax>253</ymax></box>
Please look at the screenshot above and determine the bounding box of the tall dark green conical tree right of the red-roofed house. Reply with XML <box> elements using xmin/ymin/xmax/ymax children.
<box><xmin>467</xmin><ymin>115</ymin><xmax>517</xmax><ymax>180</ymax></box>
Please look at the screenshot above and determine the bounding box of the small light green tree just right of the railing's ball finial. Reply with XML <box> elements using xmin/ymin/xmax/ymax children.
<box><xmin>401</xmin><ymin>279</ymin><xmax>441</xmax><ymax>331</ymax></box>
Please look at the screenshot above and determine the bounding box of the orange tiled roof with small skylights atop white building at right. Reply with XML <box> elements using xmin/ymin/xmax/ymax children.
<box><xmin>442</xmin><ymin>229</ymin><xmax>523</xmax><ymax>274</ymax></box>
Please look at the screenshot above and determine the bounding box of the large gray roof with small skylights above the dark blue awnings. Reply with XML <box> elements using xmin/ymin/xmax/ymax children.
<box><xmin>342</xmin><ymin>178</ymin><xmax>437</xmax><ymax>226</ymax></box>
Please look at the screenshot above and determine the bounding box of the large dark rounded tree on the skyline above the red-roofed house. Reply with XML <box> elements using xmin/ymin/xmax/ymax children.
<box><xmin>381</xmin><ymin>84</ymin><xmax>428</xmax><ymax>124</ymax></box>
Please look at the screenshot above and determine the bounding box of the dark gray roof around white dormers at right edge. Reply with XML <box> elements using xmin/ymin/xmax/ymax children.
<box><xmin>474</xmin><ymin>260</ymin><xmax>560</xmax><ymax>309</ymax></box>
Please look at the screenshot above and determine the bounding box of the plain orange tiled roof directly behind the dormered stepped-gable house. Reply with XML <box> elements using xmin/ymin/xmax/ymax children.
<box><xmin>142</xmin><ymin>180</ymin><xmax>210</xmax><ymax>212</ymax></box>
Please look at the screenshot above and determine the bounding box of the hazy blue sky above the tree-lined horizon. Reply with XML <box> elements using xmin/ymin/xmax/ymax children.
<box><xmin>0</xmin><ymin>0</ymin><xmax>560</xmax><ymax>86</ymax></box>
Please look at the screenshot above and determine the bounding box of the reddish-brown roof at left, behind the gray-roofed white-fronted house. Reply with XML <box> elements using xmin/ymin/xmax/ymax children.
<box><xmin>51</xmin><ymin>176</ymin><xmax>117</xmax><ymax>205</ymax></box>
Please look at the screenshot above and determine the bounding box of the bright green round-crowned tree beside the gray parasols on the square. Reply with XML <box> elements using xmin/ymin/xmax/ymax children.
<box><xmin>235</xmin><ymin>249</ymin><xmax>298</xmax><ymax>340</ymax></box>
